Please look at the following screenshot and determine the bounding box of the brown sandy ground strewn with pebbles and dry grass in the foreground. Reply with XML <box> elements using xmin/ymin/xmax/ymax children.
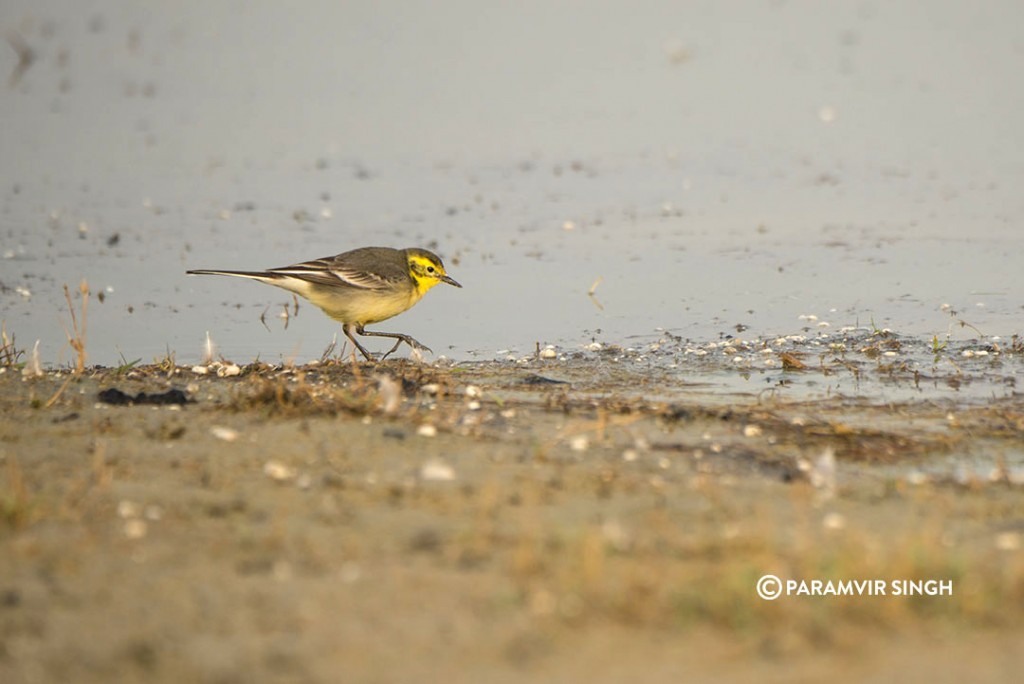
<box><xmin>0</xmin><ymin>360</ymin><xmax>1024</xmax><ymax>684</ymax></box>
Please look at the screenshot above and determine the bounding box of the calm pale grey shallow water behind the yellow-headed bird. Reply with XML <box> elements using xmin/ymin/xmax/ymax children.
<box><xmin>0</xmin><ymin>2</ymin><xmax>1024</xmax><ymax>374</ymax></box>
